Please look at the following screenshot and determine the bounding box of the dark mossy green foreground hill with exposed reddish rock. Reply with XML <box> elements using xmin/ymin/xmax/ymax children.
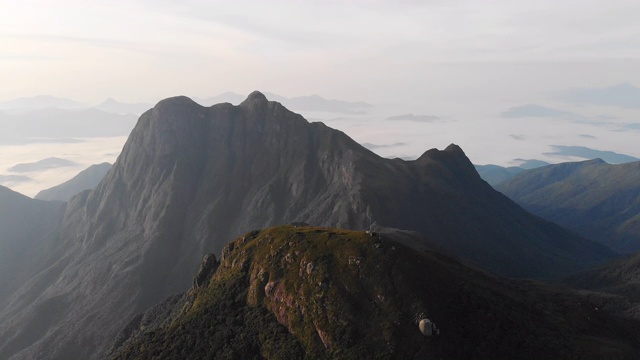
<box><xmin>110</xmin><ymin>226</ymin><xmax>640</xmax><ymax>359</ymax></box>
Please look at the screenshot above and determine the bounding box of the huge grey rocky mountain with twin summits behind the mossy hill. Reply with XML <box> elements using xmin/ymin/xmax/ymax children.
<box><xmin>0</xmin><ymin>92</ymin><xmax>612</xmax><ymax>359</ymax></box>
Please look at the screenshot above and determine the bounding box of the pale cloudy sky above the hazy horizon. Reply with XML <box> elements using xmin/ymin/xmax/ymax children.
<box><xmin>0</xmin><ymin>0</ymin><xmax>640</xmax><ymax>102</ymax></box>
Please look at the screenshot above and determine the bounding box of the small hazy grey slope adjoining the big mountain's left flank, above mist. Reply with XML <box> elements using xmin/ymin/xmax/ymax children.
<box><xmin>34</xmin><ymin>163</ymin><xmax>111</xmax><ymax>201</ymax></box>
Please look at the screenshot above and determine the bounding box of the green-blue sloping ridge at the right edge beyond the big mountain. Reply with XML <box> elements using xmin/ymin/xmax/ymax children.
<box><xmin>497</xmin><ymin>159</ymin><xmax>640</xmax><ymax>253</ymax></box>
